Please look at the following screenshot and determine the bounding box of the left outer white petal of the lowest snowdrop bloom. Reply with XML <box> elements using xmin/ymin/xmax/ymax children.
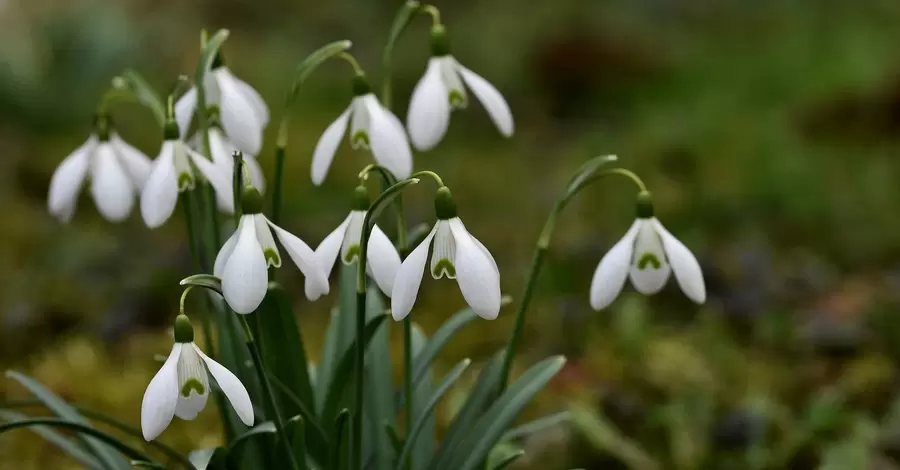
<box><xmin>141</xmin><ymin>343</ymin><xmax>183</xmax><ymax>442</ymax></box>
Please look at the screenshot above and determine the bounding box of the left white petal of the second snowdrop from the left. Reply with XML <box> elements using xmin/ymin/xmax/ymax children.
<box><xmin>141</xmin><ymin>140</ymin><xmax>178</xmax><ymax>228</ymax></box>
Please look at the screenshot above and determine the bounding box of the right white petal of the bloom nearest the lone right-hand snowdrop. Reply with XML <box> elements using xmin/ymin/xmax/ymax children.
<box><xmin>449</xmin><ymin>218</ymin><xmax>500</xmax><ymax>320</ymax></box>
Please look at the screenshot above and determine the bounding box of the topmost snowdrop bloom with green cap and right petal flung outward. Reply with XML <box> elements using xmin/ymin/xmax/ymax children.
<box><xmin>406</xmin><ymin>25</ymin><xmax>514</xmax><ymax>150</ymax></box>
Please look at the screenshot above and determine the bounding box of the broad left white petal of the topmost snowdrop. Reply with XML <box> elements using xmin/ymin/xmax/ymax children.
<box><xmin>406</xmin><ymin>58</ymin><xmax>450</xmax><ymax>150</ymax></box>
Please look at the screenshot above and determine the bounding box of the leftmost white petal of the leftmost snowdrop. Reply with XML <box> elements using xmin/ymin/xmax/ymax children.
<box><xmin>47</xmin><ymin>136</ymin><xmax>97</xmax><ymax>222</ymax></box>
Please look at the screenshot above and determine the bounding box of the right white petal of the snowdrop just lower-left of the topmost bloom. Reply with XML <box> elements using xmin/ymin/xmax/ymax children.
<box><xmin>364</xmin><ymin>94</ymin><xmax>412</xmax><ymax>179</ymax></box>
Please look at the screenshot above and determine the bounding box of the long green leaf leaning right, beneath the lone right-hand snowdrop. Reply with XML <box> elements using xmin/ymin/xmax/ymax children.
<box><xmin>450</xmin><ymin>356</ymin><xmax>566</xmax><ymax>470</ymax></box>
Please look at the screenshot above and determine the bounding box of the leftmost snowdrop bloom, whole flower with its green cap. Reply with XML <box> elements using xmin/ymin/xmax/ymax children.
<box><xmin>47</xmin><ymin>116</ymin><xmax>150</xmax><ymax>222</ymax></box>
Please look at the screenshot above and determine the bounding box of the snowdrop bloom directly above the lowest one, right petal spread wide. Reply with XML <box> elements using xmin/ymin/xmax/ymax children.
<box><xmin>213</xmin><ymin>187</ymin><xmax>329</xmax><ymax>314</ymax></box>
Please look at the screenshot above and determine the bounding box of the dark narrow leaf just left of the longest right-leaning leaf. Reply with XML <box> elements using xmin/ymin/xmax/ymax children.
<box><xmin>432</xmin><ymin>351</ymin><xmax>504</xmax><ymax>470</ymax></box>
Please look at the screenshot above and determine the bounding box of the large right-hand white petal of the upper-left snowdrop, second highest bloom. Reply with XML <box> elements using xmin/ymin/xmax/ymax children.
<box><xmin>213</xmin><ymin>67</ymin><xmax>265</xmax><ymax>155</ymax></box>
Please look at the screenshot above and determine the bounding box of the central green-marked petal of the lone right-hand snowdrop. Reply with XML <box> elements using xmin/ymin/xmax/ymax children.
<box><xmin>630</xmin><ymin>219</ymin><xmax>672</xmax><ymax>295</ymax></box>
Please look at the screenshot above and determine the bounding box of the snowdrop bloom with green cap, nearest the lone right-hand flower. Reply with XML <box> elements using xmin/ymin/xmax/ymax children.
<box><xmin>391</xmin><ymin>186</ymin><xmax>500</xmax><ymax>321</ymax></box>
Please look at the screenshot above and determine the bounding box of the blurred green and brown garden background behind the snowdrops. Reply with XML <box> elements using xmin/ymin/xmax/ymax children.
<box><xmin>0</xmin><ymin>0</ymin><xmax>900</xmax><ymax>470</ymax></box>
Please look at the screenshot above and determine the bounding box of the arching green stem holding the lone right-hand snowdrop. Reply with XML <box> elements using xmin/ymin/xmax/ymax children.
<box><xmin>500</xmin><ymin>165</ymin><xmax>647</xmax><ymax>392</ymax></box>
